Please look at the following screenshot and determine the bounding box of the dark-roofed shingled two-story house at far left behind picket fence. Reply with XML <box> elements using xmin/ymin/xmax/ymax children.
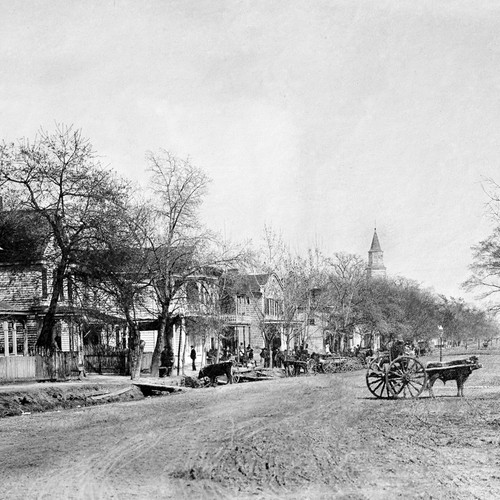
<box><xmin>0</xmin><ymin>210</ymin><xmax>127</xmax><ymax>356</ymax></box>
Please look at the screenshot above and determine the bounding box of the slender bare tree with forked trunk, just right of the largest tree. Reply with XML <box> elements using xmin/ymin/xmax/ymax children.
<box><xmin>141</xmin><ymin>150</ymin><xmax>243</xmax><ymax>375</ymax></box>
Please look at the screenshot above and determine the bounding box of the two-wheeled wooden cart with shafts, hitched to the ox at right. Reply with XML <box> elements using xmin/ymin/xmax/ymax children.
<box><xmin>366</xmin><ymin>353</ymin><xmax>481</xmax><ymax>399</ymax></box>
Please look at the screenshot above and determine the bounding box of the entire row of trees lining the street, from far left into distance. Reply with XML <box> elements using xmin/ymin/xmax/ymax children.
<box><xmin>0</xmin><ymin>125</ymin><xmax>496</xmax><ymax>375</ymax></box>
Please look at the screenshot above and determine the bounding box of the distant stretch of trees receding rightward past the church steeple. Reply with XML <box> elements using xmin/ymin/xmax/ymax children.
<box><xmin>254</xmin><ymin>232</ymin><xmax>499</xmax><ymax>351</ymax></box>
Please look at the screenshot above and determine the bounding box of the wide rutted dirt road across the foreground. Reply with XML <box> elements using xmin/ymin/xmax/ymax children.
<box><xmin>0</xmin><ymin>358</ymin><xmax>500</xmax><ymax>500</ymax></box>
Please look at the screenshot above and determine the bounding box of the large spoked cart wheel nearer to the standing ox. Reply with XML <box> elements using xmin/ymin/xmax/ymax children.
<box><xmin>387</xmin><ymin>356</ymin><xmax>427</xmax><ymax>398</ymax></box>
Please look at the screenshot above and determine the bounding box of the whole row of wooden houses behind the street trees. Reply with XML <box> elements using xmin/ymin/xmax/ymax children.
<box><xmin>0</xmin><ymin>211</ymin><xmax>332</xmax><ymax>372</ymax></box>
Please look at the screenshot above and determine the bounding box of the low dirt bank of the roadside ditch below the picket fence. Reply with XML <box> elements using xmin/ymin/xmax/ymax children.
<box><xmin>0</xmin><ymin>384</ymin><xmax>144</xmax><ymax>417</ymax></box>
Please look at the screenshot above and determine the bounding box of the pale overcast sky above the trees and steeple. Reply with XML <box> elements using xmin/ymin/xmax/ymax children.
<box><xmin>0</xmin><ymin>0</ymin><xmax>500</xmax><ymax>299</ymax></box>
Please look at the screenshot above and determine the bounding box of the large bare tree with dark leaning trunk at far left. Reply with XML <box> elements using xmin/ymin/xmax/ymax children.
<box><xmin>0</xmin><ymin>125</ymin><xmax>128</xmax><ymax>348</ymax></box>
